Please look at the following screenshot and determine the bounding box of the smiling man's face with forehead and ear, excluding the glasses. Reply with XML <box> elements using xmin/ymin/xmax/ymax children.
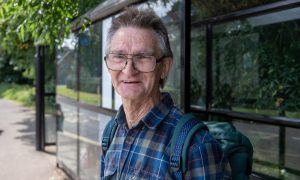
<box><xmin>109</xmin><ymin>27</ymin><xmax>171</xmax><ymax>100</ymax></box>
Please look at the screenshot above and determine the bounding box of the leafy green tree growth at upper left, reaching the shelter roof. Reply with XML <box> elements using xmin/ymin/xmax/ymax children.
<box><xmin>0</xmin><ymin>0</ymin><xmax>101</xmax><ymax>83</ymax></box>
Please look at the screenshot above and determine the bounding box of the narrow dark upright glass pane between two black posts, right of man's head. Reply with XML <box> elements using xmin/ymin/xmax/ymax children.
<box><xmin>190</xmin><ymin>27</ymin><xmax>206</xmax><ymax>108</ymax></box>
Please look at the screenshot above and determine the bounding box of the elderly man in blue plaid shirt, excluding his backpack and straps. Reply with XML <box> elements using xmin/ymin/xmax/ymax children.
<box><xmin>101</xmin><ymin>8</ymin><xmax>227</xmax><ymax>180</ymax></box>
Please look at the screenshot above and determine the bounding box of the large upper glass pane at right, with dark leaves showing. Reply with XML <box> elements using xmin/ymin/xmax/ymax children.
<box><xmin>213</xmin><ymin>8</ymin><xmax>300</xmax><ymax>118</ymax></box>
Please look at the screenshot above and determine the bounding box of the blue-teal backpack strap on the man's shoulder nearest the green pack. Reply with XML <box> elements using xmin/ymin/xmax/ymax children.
<box><xmin>170</xmin><ymin>114</ymin><xmax>208</xmax><ymax>179</ymax></box>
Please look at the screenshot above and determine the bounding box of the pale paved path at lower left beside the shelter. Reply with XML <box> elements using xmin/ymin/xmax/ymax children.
<box><xmin>0</xmin><ymin>99</ymin><xmax>69</xmax><ymax>180</ymax></box>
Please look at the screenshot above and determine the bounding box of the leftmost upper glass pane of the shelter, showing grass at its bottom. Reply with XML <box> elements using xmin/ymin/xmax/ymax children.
<box><xmin>56</xmin><ymin>34</ymin><xmax>77</xmax><ymax>99</ymax></box>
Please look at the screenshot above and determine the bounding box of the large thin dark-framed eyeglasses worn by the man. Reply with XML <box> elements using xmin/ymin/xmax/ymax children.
<box><xmin>104</xmin><ymin>53</ymin><xmax>166</xmax><ymax>72</ymax></box>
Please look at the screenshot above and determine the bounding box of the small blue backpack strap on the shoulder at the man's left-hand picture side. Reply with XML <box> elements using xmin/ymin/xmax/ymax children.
<box><xmin>101</xmin><ymin>119</ymin><xmax>118</xmax><ymax>153</ymax></box>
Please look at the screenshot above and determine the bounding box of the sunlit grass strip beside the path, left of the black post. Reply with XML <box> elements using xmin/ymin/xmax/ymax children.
<box><xmin>0</xmin><ymin>83</ymin><xmax>35</xmax><ymax>108</ymax></box>
